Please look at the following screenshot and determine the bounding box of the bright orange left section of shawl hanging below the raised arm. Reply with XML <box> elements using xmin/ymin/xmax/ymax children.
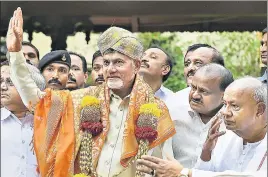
<box><xmin>34</xmin><ymin>89</ymin><xmax>75</xmax><ymax>177</ymax></box>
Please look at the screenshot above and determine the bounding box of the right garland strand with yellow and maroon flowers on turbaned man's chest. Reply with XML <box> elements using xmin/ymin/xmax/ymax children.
<box><xmin>135</xmin><ymin>103</ymin><xmax>161</xmax><ymax>177</ymax></box>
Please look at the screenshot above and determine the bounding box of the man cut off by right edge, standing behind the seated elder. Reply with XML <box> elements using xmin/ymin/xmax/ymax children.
<box><xmin>259</xmin><ymin>28</ymin><xmax>267</xmax><ymax>84</ymax></box>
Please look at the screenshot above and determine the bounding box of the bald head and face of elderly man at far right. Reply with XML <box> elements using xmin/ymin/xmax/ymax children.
<box><xmin>222</xmin><ymin>76</ymin><xmax>267</xmax><ymax>136</ymax></box>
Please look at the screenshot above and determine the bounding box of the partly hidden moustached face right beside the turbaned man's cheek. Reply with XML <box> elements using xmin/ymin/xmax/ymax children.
<box><xmin>91</xmin><ymin>50</ymin><xmax>104</xmax><ymax>85</ymax></box>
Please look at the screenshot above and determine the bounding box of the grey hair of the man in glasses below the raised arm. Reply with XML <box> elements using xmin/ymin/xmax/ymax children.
<box><xmin>26</xmin><ymin>63</ymin><xmax>46</xmax><ymax>91</ymax></box>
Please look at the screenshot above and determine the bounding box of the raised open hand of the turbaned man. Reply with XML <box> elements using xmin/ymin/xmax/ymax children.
<box><xmin>6</xmin><ymin>7</ymin><xmax>23</xmax><ymax>52</ymax></box>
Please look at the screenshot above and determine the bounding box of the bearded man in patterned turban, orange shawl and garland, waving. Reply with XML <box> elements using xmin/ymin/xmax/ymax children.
<box><xmin>7</xmin><ymin>8</ymin><xmax>175</xmax><ymax>177</ymax></box>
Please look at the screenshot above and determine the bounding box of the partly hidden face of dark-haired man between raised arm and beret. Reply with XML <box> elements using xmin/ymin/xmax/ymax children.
<box><xmin>22</xmin><ymin>41</ymin><xmax>39</xmax><ymax>67</ymax></box>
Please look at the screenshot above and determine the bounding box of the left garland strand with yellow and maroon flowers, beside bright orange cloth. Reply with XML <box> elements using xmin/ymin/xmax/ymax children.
<box><xmin>74</xmin><ymin>96</ymin><xmax>103</xmax><ymax>177</ymax></box>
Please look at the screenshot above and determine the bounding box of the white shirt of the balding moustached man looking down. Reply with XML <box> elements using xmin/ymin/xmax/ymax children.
<box><xmin>170</xmin><ymin>103</ymin><xmax>215</xmax><ymax>168</ymax></box>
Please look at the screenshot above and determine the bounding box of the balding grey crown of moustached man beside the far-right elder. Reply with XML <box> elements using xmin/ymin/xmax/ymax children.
<box><xmin>195</xmin><ymin>63</ymin><xmax>234</xmax><ymax>91</ymax></box>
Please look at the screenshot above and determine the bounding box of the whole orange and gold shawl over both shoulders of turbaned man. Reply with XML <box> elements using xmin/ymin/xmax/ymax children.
<box><xmin>34</xmin><ymin>76</ymin><xmax>175</xmax><ymax>177</ymax></box>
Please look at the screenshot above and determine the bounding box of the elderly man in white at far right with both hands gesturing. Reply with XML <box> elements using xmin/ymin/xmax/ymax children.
<box><xmin>140</xmin><ymin>77</ymin><xmax>267</xmax><ymax>177</ymax></box>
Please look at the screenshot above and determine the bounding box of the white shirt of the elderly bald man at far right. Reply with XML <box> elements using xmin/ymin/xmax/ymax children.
<box><xmin>193</xmin><ymin>130</ymin><xmax>267</xmax><ymax>177</ymax></box>
